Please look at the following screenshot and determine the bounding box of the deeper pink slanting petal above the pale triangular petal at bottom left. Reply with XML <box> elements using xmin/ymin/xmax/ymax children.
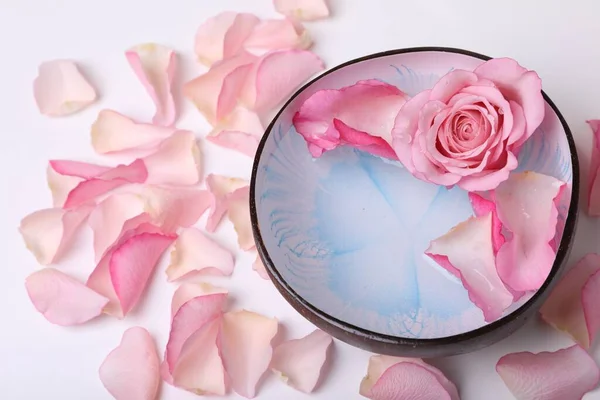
<box><xmin>163</xmin><ymin>286</ymin><xmax>227</xmax><ymax>378</ymax></box>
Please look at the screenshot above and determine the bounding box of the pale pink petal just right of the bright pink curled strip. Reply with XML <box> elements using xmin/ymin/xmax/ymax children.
<box><xmin>142</xmin><ymin>131</ymin><xmax>202</xmax><ymax>185</ymax></box>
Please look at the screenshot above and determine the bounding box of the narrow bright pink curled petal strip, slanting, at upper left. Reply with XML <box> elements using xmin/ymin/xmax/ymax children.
<box><xmin>63</xmin><ymin>160</ymin><xmax>148</xmax><ymax>208</ymax></box>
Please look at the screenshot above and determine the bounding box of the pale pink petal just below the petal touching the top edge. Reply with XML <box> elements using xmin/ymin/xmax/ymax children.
<box><xmin>244</xmin><ymin>18</ymin><xmax>312</xmax><ymax>55</ymax></box>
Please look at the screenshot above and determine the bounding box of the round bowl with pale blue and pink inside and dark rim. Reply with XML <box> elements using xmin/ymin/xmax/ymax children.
<box><xmin>250</xmin><ymin>47</ymin><xmax>579</xmax><ymax>358</ymax></box>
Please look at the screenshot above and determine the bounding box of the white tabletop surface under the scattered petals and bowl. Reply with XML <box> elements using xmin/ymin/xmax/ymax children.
<box><xmin>0</xmin><ymin>0</ymin><xmax>600</xmax><ymax>400</ymax></box>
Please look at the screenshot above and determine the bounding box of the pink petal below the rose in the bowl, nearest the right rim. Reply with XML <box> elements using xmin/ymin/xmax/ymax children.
<box><xmin>494</xmin><ymin>171</ymin><xmax>564</xmax><ymax>291</ymax></box>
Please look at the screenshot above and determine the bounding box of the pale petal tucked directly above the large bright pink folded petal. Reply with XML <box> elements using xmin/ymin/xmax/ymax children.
<box><xmin>88</xmin><ymin>193</ymin><xmax>145</xmax><ymax>262</ymax></box>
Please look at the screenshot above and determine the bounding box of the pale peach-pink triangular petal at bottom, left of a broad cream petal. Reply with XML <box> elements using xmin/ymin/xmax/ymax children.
<box><xmin>173</xmin><ymin>318</ymin><xmax>227</xmax><ymax>396</ymax></box>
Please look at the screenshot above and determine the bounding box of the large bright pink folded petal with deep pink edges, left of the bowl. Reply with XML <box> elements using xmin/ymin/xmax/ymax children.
<box><xmin>87</xmin><ymin>228</ymin><xmax>176</xmax><ymax>318</ymax></box>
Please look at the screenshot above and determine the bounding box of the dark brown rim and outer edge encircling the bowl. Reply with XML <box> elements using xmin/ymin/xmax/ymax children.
<box><xmin>250</xmin><ymin>46</ymin><xmax>580</xmax><ymax>354</ymax></box>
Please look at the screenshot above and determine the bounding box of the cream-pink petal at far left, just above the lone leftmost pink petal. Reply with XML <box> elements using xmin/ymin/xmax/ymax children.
<box><xmin>19</xmin><ymin>206</ymin><xmax>93</xmax><ymax>265</ymax></box>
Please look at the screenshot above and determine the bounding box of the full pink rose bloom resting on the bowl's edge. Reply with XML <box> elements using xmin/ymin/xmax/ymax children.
<box><xmin>392</xmin><ymin>58</ymin><xmax>544</xmax><ymax>191</ymax></box>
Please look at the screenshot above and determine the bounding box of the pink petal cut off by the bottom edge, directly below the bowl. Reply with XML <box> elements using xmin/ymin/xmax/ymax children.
<box><xmin>360</xmin><ymin>356</ymin><xmax>460</xmax><ymax>400</ymax></box>
